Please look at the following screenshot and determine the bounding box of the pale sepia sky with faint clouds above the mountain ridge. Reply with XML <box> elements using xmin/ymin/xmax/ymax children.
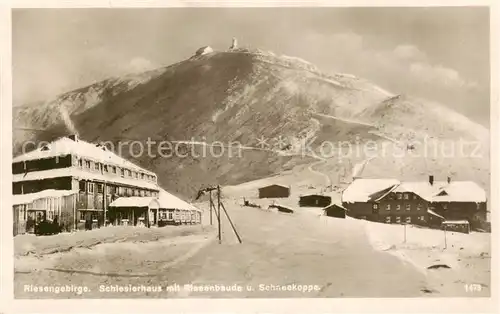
<box><xmin>12</xmin><ymin>7</ymin><xmax>490</xmax><ymax>124</ymax></box>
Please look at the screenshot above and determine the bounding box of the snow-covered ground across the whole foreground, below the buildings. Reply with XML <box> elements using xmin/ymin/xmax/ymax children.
<box><xmin>14</xmin><ymin>197</ymin><xmax>489</xmax><ymax>298</ymax></box>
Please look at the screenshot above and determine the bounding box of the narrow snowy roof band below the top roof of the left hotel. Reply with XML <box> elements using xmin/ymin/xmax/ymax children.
<box><xmin>12</xmin><ymin>167</ymin><xmax>158</xmax><ymax>191</ymax></box>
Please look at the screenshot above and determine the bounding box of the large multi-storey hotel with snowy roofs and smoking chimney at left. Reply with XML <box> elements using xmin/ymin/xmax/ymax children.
<box><xmin>12</xmin><ymin>135</ymin><xmax>201</xmax><ymax>234</ymax></box>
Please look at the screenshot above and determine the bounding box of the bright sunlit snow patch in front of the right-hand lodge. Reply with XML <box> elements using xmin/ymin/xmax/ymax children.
<box><xmin>358</xmin><ymin>219</ymin><xmax>491</xmax><ymax>297</ymax></box>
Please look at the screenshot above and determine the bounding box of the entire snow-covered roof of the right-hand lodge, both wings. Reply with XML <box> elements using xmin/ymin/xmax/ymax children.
<box><xmin>342</xmin><ymin>179</ymin><xmax>486</xmax><ymax>203</ymax></box>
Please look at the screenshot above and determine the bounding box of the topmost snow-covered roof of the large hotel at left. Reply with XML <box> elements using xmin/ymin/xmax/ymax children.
<box><xmin>12</xmin><ymin>137</ymin><xmax>154</xmax><ymax>174</ymax></box>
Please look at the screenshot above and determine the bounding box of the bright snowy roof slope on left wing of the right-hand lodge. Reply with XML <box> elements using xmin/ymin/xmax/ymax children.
<box><xmin>342</xmin><ymin>179</ymin><xmax>399</xmax><ymax>203</ymax></box>
